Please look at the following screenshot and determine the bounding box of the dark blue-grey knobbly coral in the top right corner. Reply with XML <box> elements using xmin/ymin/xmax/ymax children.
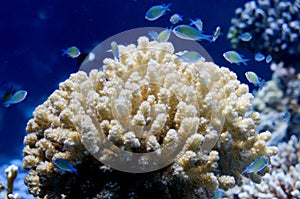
<box><xmin>227</xmin><ymin>0</ymin><xmax>300</xmax><ymax>70</ymax></box>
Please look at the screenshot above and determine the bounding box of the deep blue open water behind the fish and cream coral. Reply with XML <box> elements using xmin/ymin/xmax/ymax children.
<box><xmin>0</xmin><ymin>0</ymin><xmax>270</xmax><ymax>159</ymax></box>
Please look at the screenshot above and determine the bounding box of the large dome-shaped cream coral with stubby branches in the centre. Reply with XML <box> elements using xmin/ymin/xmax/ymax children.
<box><xmin>23</xmin><ymin>37</ymin><xmax>277</xmax><ymax>199</ymax></box>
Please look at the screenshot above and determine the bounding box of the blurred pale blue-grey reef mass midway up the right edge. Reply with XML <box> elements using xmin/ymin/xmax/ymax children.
<box><xmin>253</xmin><ymin>63</ymin><xmax>300</xmax><ymax>145</ymax></box>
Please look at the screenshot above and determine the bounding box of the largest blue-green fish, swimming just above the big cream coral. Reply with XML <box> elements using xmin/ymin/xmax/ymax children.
<box><xmin>173</xmin><ymin>25</ymin><xmax>213</xmax><ymax>42</ymax></box>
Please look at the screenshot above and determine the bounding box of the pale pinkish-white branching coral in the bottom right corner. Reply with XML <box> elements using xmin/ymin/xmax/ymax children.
<box><xmin>225</xmin><ymin>136</ymin><xmax>300</xmax><ymax>199</ymax></box>
